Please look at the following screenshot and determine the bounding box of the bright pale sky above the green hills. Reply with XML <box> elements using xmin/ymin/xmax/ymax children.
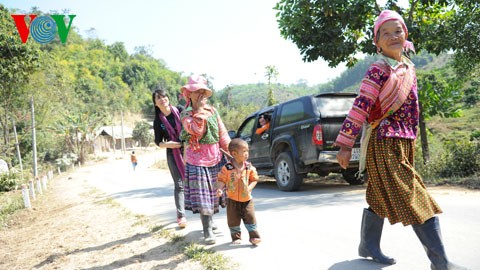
<box><xmin>0</xmin><ymin>0</ymin><xmax>346</xmax><ymax>89</ymax></box>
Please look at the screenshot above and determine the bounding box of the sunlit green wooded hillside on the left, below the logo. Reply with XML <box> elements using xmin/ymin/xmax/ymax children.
<box><xmin>0</xmin><ymin>5</ymin><xmax>185</xmax><ymax>175</ymax></box>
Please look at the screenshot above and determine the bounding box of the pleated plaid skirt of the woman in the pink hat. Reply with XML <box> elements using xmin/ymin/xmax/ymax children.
<box><xmin>183</xmin><ymin>159</ymin><xmax>225</xmax><ymax>216</ymax></box>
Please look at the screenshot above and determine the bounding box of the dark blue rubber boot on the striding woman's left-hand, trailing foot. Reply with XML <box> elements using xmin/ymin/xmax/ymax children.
<box><xmin>358</xmin><ymin>209</ymin><xmax>396</xmax><ymax>264</ymax></box>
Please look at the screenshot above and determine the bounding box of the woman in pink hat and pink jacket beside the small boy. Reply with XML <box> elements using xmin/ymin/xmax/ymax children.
<box><xmin>180</xmin><ymin>76</ymin><xmax>230</xmax><ymax>244</ymax></box>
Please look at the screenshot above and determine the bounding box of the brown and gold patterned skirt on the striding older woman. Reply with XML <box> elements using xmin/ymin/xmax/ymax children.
<box><xmin>366</xmin><ymin>133</ymin><xmax>442</xmax><ymax>226</ymax></box>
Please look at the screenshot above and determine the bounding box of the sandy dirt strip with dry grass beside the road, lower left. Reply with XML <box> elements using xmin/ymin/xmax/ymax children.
<box><xmin>0</xmin><ymin>153</ymin><xmax>202</xmax><ymax>269</ymax></box>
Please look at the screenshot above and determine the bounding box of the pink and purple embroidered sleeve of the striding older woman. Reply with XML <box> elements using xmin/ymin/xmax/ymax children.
<box><xmin>335</xmin><ymin>64</ymin><xmax>388</xmax><ymax>148</ymax></box>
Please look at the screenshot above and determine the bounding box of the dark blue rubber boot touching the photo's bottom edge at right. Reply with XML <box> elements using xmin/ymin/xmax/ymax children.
<box><xmin>412</xmin><ymin>217</ymin><xmax>467</xmax><ymax>270</ymax></box>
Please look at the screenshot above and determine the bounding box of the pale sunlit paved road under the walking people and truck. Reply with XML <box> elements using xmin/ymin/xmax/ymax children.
<box><xmin>78</xmin><ymin>149</ymin><xmax>480</xmax><ymax>270</ymax></box>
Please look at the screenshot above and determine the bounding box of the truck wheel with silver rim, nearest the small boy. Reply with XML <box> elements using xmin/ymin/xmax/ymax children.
<box><xmin>274</xmin><ymin>152</ymin><xmax>303</xmax><ymax>191</ymax></box>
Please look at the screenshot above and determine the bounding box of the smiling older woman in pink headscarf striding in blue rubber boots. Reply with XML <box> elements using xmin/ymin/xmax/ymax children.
<box><xmin>335</xmin><ymin>10</ymin><xmax>461</xmax><ymax>269</ymax></box>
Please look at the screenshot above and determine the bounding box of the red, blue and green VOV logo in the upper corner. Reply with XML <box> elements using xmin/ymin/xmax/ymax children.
<box><xmin>11</xmin><ymin>14</ymin><xmax>77</xmax><ymax>44</ymax></box>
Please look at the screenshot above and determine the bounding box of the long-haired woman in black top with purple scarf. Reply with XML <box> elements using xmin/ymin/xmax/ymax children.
<box><xmin>152</xmin><ymin>89</ymin><xmax>187</xmax><ymax>228</ymax></box>
